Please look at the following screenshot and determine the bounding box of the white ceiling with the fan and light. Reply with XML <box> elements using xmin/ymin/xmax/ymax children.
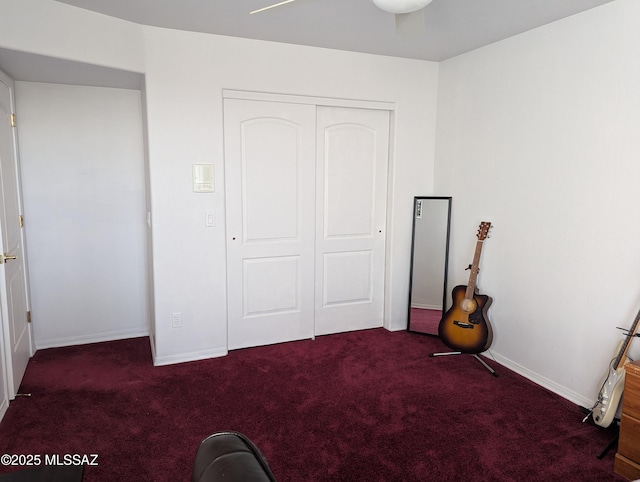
<box><xmin>56</xmin><ymin>0</ymin><xmax>613</xmax><ymax>61</ymax></box>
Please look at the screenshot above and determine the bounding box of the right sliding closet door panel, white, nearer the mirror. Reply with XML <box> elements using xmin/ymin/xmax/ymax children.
<box><xmin>315</xmin><ymin>107</ymin><xmax>389</xmax><ymax>335</ymax></box>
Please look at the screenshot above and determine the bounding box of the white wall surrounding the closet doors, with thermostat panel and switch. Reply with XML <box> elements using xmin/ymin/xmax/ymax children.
<box><xmin>0</xmin><ymin>0</ymin><xmax>438</xmax><ymax>363</ymax></box>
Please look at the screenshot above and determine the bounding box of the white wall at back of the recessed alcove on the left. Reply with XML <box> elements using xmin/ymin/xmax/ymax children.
<box><xmin>16</xmin><ymin>82</ymin><xmax>149</xmax><ymax>348</ymax></box>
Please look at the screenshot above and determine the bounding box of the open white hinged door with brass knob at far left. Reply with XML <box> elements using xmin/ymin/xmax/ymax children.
<box><xmin>0</xmin><ymin>81</ymin><xmax>31</xmax><ymax>398</ymax></box>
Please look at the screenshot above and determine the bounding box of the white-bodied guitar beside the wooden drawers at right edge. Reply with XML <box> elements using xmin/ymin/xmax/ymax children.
<box><xmin>585</xmin><ymin>311</ymin><xmax>640</xmax><ymax>428</ymax></box>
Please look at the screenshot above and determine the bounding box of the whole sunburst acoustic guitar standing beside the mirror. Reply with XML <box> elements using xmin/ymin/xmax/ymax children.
<box><xmin>438</xmin><ymin>222</ymin><xmax>493</xmax><ymax>354</ymax></box>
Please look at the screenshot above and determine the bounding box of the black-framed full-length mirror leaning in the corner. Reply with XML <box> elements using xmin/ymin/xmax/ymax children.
<box><xmin>407</xmin><ymin>196</ymin><xmax>451</xmax><ymax>336</ymax></box>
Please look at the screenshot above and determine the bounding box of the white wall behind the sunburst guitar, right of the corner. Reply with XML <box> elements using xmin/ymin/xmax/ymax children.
<box><xmin>435</xmin><ymin>0</ymin><xmax>640</xmax><ymax>405</ymax></box>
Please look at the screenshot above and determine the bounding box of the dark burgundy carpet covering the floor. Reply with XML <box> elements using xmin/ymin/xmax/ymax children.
<box><xmin>0</xmin><ymin>329</ymin><xmax>622</xmax><ymax>482</ymax></box>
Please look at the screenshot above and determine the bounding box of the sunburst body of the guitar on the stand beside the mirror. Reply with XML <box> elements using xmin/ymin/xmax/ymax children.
<box><xmin>438</xmin><ymin>285</ymin><xmax>493</xmax><ymax>354</ymax></box>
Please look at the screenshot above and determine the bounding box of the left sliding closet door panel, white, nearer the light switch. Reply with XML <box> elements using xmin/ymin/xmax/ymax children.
<box><xmin>224</xmin><ymin>99</ymin><xmax>315</xmax><ymax>349</ymax></box>
